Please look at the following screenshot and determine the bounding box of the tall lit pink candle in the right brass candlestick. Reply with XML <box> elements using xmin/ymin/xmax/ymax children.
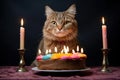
<box><xmin>102</xmin><ymin>17</ymin><xmax>107</xmax><ymax>49</ymax></box>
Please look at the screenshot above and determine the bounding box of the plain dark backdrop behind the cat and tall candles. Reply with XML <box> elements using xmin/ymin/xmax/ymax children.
<box><xmin>0</xmin><ymin>0</ymin><xmax>120</xmax><ymax>66</ymax></box>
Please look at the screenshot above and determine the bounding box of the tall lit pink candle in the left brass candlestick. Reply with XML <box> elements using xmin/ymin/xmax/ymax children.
<box><xmin>20</xmin><ymin>18</ymin><xmax>25</xmax><ymax>49</ymax></box>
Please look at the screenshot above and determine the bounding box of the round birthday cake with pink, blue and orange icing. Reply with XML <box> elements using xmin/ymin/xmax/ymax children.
<box><xmin>36</xmin><ymin>53</ymin><xmax>87</xmax><ymax>70</ymax></box>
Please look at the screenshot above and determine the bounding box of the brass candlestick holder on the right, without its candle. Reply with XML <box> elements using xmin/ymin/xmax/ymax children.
<box><xmin>101</xmin><ymin>49</ymin><xmax>110</xmax><ymax>72</ymax></box>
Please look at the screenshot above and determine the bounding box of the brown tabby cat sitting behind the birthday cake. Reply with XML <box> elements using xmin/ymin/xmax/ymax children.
<box><xmin>33</xmin><ymin>4</ymin><xmax>79</xmax><ymax>64</ymax></box>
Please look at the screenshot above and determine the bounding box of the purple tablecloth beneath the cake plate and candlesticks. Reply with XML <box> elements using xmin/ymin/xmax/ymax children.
<box><xmin>0</xmin><ymin>66</ymin><xmax>120</xmax><ymax>80</ymax></box>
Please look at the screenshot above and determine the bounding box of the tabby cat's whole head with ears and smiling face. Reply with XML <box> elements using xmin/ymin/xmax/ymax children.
<box><xmin>43</xmin><ymin>5</ymin><xmax>77</xmax><ymax>40</ymax></box>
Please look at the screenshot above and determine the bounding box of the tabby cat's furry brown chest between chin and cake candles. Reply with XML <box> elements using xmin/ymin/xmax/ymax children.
<box><xmin>43</xmin><ymin>39</ymin><xmax>79</xmax><ymax>52</ymax></box>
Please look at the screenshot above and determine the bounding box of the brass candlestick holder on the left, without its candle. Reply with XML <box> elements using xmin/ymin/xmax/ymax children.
<box><xmin>17</xmin><ymin>49</ymin><xmax>27</xmax><ymax>72</ymax></box>
